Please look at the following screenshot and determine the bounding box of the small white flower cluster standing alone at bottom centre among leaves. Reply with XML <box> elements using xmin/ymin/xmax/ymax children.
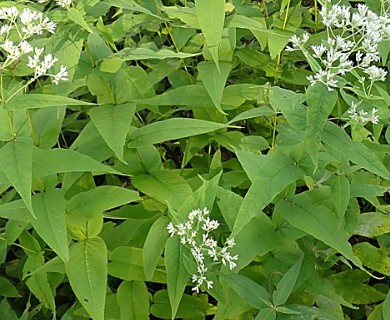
<box><xmin>167</xmin><ymin>208</ymin><xmax>238</xmax><ymax>293</ymax></box>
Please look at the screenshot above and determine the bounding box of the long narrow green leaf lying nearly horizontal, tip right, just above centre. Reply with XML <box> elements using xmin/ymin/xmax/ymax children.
<box><xmin>128</xmin><ymin>118</ymin><xmax>227</xmax><ymax>147</ymax></box>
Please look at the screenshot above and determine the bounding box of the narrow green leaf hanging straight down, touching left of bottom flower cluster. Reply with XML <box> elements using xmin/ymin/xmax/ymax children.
<box><xmin>164</xmin><ymin>237</ymin><xmax>189</xmax><ymax>319</ymax></box>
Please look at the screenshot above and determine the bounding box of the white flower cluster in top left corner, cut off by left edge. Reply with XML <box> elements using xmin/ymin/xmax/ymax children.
<box><xmin>0</xmin><ymin>7</ymin><xmax>68</xmax><ymax>84</ymax></box>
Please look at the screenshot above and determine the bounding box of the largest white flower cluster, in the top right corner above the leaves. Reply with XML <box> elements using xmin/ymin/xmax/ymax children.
<box><xmin>287</xmin><ymin>4</ymin><xmax>390</xmax><ymax>95</ymax></box>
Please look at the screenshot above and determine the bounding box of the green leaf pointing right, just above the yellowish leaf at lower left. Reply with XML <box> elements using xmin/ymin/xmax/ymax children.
<box><xmin>66</xmin><ymin>185</ymin><xmax>141</xmax><ymax>218</ymax></box>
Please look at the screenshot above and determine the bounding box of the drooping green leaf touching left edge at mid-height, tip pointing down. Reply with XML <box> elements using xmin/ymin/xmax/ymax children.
<box><xmin>0</xmin><ymin>137</ymin><xmax>35</xmax><ymax>218</ymax></box>
